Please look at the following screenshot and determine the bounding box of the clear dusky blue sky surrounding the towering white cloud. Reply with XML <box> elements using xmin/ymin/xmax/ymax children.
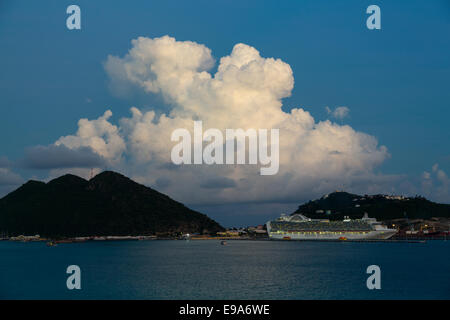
<box><xmin>0</xmin><ymin>0</ymin><xmax>450</xmax><ymax>225</ymax></box>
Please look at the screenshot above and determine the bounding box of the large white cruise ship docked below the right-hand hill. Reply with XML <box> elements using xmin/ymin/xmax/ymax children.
<box><xmin>266</xmin><ymin>213</ymin><xmax>397</xmax><ymax>240</ymax></box>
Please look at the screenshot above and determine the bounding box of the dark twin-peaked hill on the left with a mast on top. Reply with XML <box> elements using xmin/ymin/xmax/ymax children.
<box><xmin>0</xmin><ymin>171</ymin><xmax>223</xmax><ymax>237</ymax></box>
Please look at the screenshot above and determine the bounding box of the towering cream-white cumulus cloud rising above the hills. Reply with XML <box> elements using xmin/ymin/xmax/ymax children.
<box><xmin>52</xmin><ymin>36</ymin><xmax>388</xmax><ymax>203</ymax></box>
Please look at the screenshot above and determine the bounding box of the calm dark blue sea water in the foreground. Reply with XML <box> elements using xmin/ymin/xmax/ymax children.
<box><xmin>0</xmin><ymin>241</ymin><xmax>450</xmax><ymax>299</ymax></box>
